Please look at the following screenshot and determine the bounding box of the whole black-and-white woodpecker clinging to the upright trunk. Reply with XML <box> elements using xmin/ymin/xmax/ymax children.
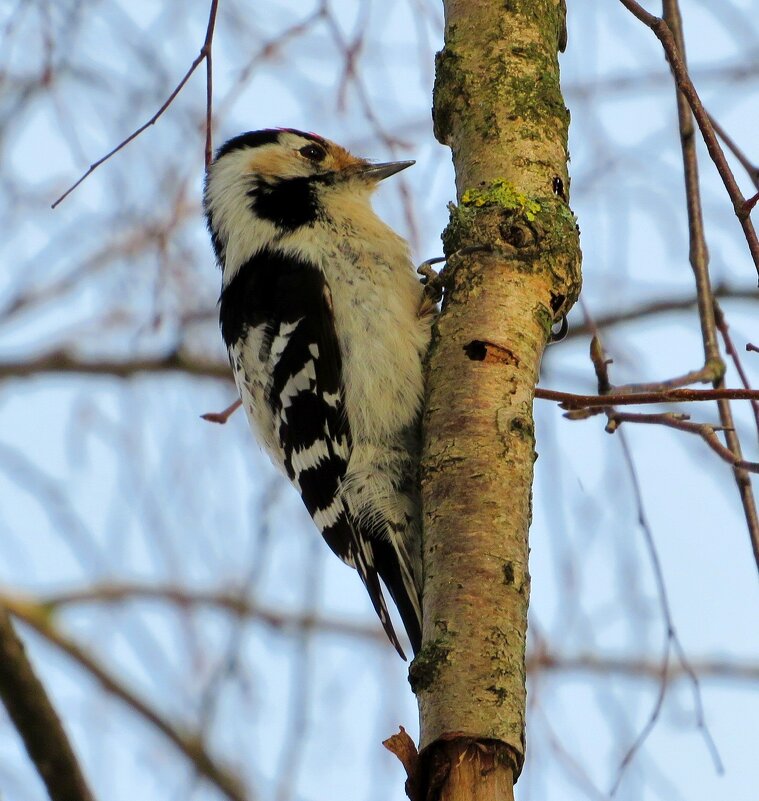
<box><xmin>203</xmin><ymin>129</ymin><xmax>434</xmax><ymax>659</ymax></box>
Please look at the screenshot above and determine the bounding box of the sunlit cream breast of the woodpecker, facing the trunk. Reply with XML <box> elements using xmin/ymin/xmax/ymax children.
<box><xmin>282</xmin><ymin>193</ymin><xmax>430</xmax><ymax>442</ymax></box>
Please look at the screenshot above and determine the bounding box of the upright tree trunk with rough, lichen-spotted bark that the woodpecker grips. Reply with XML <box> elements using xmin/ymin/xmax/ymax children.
<box><xmin>410</xmin><ymin>0</ymin><xmax>580</xmax><ymax>801</ymax></box>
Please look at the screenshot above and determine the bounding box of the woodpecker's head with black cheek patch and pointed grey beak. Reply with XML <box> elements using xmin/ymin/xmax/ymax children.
<box><xmin>203</xmin><ymin>129</ymin><xmax>414</xmax><ymax>267</ymax></box>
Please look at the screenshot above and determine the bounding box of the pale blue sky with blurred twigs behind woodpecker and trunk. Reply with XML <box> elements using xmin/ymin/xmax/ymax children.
<box><xmin>0</xmin><ymin>0</ymin><xmax>759</xmax><ymax>801</ymax></box>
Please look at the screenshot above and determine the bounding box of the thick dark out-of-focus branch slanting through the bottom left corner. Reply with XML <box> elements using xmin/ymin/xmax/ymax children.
<box><xmin>0</xmin><ymin>603</ymin><xmax>93</xmax><ymax>801</ymax></box>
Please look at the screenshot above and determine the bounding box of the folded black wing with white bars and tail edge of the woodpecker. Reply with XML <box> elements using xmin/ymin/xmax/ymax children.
<box><xmin>220</xmin><ymin>250</ymin><xmax>412</xmax><ymax>658</ymax></box>
